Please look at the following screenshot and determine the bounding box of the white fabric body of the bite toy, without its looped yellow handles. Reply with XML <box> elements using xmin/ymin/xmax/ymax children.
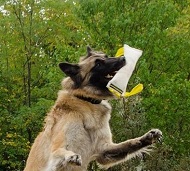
<box><xmin>107</xmin><ymin>44</ymin><xmax>142</xmax><ymax>97</ymax></box>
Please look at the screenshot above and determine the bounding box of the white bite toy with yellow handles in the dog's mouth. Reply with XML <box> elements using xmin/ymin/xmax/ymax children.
<box><xmin>107</xmin><ymin>44</ymin><xmax>143</xmax><ymax>98</ymax></box>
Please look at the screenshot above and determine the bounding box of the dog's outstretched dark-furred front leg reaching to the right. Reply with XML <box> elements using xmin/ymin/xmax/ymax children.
<box><xmin>97</xmin><ymin>129</ymin><xmax>162</xmax><ymax>168</ymax></box>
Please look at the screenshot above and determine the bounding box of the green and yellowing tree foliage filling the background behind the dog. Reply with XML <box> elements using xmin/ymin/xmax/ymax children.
<box><xmin>0</xmin><ymin>0</ymin><xmax>190</xmax><ymax>171</ymax></box>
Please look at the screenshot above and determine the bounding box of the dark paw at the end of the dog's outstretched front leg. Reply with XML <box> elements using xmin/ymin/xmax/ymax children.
<box><xmin>140</xmin><ymin>129</ymin><xmax>163</xmax><ymax>145</ymax></box>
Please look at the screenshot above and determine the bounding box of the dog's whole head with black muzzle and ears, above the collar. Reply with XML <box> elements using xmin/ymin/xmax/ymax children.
<box><xmin>59</xmin><ymin>47</ymin><xmax>125</xmax><ymax>99</ymax></box>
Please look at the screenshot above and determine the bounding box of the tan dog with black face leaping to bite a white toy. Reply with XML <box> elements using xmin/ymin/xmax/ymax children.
<box><xmin>24</xmin><ymin>47</ymin><xmax>162</xmax><ymax>171</ymax></box>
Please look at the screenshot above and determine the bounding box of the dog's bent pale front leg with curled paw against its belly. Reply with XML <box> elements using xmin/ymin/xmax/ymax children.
<box><xmin>45</xmin><ymin>148</ymin><xmax>82</xmax><ymax>171</ymax></box>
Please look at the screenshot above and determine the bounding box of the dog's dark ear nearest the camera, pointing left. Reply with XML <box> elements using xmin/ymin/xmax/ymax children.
<box><xmin>59</xmin><ymin>62</ymin><xmax>82</xmax><ymax>88</ymax></box>
